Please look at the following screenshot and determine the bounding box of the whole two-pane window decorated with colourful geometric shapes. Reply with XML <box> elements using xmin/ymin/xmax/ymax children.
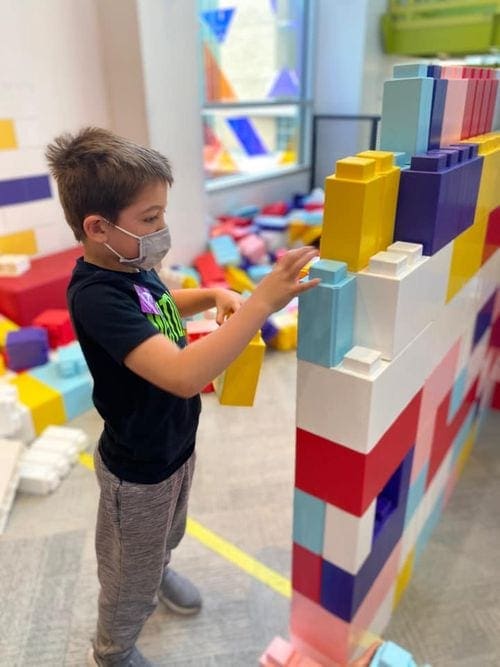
<box><xmin>198</xmin><ymin>0</ymin><xmax>311</xmax><ymax>189</ymax></box>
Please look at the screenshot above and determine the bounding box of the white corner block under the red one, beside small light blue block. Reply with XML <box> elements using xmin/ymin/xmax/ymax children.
<box><xmin>323</xmin><ymin>500</ymin><xmax>377</xmax><ymax>574</ymax></box>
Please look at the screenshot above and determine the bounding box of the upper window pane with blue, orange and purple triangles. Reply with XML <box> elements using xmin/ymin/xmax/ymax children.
<box><xmin>199</xmin><ymin>0</ymin><xmax>305</xmax><ymax>104</ymax></box>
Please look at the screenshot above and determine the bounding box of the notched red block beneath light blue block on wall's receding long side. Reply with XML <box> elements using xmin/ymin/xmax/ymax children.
<box><xmin>425</xmin><ymin>380</ymin><xmax>478</xmax><ymax>489</ymax></box>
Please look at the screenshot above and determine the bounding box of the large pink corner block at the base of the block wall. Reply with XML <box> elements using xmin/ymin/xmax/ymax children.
<box><xmin>290</xmin><ymin>540</ymin><xmax>401</xmax><ymax>667</ymax></box>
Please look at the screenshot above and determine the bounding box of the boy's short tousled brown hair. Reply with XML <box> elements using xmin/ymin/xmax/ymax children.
<box><xmin>45</xmin><ymin>127</ymin><xmax>173</xmax><ymax>241</ymax></box>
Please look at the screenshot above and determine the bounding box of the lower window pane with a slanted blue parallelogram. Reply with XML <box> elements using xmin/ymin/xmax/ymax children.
<box><xmin>203</xmin><ymin>105</ymin><xmax>299</xmax><ymax>179</ymax></box>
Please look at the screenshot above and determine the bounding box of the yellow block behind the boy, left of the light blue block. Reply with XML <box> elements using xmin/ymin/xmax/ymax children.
<box><xmin>10</xmin><ymin>373</ymin><xmax>66</xmax><ymax>435</ymax></box>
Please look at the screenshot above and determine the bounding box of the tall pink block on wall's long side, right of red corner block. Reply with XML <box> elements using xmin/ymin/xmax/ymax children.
<box><xmin>410</xmin><ymin>339</ymin><xmax>460</xmax><ymax>484</ymax></box>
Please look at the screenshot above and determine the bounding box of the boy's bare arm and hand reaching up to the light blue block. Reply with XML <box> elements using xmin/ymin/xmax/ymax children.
<box><xmin>124</xmin><ymin>247</ymin><xmax>319</xmax><ymax>398</ymax></box>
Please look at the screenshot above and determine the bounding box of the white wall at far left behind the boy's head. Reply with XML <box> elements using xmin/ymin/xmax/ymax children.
<box><xmin>0</xmin><ymin>0</ymin><xmax>109</xmax><ymax>254</ymax></box>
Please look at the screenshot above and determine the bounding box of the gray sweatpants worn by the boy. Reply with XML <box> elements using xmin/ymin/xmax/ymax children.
<box><xmin>94</xmin><ymin>448</ymin><xmax>195</xmax><ymax>666</ymax></box>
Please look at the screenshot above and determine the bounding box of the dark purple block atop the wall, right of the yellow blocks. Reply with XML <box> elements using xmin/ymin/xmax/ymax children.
<box><xmin>394</xmin><ymin>147</ymin><xmax>482</xmax><ymax>255</ymax></box>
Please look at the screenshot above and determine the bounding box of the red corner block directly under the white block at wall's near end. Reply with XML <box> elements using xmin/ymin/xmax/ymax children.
<box><xmin>295</xmin><ymin>390</ymin><xmax>422</xmax><ymax>516</ymax></box>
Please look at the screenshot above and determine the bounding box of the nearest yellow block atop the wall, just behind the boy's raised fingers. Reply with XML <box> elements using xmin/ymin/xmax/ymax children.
<box><xmin>320</xmin><ymin>157</ymin><xmax>384</xmax><ymax>271</ymax></box>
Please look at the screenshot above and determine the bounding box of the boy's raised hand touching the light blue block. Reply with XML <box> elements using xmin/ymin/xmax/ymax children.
<box><xmin>252</xmin><ymin>246</ymin><xmax>321</xmax><ymax>314</ymax></box>
